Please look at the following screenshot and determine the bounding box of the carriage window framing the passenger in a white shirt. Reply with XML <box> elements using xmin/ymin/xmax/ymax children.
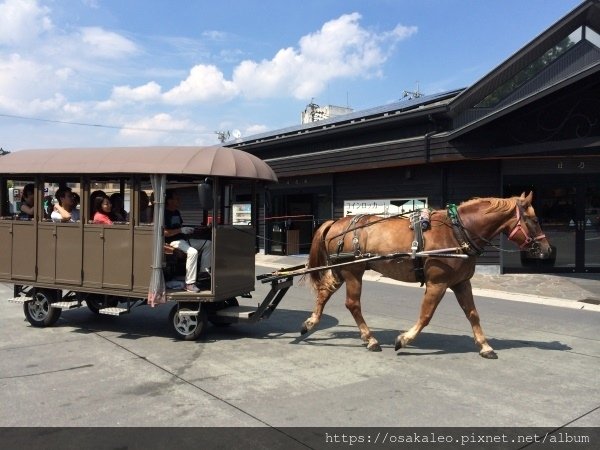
<box><xmin>42</xmin><ymin>178</ymin><xmax>81</xmax><ymax>223</ymax></box>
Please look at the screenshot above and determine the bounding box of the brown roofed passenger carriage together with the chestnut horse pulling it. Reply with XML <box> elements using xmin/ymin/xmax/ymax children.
<box><xmin>0</xmin><ymin>147</ymin><xmax>550</xmax><ymax>358</ymax></box>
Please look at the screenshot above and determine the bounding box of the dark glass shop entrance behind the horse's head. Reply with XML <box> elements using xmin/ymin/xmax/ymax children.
<box><xmin>502</xmin><ymin>174</ymin><xmax>600</xmax><ymax>273</ymax></box>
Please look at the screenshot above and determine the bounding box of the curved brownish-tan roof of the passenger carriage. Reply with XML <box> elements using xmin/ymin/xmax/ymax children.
<box><xmin>0</xmin><ymin>146</ymin><xmax>277</xmax><ymax>181</ymax></box>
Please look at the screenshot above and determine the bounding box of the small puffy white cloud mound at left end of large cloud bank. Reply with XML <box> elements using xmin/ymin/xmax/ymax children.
<box><xmin>163</xmin><ymin>65</ymin><xmax>238</xmax><ymax>105</ymax></box>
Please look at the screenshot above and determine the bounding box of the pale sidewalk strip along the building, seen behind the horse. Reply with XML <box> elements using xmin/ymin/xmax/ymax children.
<box><xmin>256</xmin><ymin>254</ymin><xmax>600</xmax><ymax>312</ymax></box>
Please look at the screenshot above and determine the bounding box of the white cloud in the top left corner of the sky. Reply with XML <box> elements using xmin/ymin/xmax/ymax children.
<box><xmin>0</xmin><ymin>0</ymin><xmax>52</xmax><ymax>45</ymax></box>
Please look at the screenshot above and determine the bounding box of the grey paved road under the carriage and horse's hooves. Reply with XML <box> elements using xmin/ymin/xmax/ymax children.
<box><xmin>0</xmin><ymin>267</ymin><xmax>600</xmax><ymax>434</ymax></box>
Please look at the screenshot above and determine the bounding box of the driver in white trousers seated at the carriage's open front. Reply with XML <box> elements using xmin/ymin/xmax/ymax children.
<box><xmin>164</xmin><ymin>189</ymin><xmax>212</xmax><ymax>292</ymax></box>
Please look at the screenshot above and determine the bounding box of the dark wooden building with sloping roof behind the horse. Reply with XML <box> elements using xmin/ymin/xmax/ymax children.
<box><xmin>232</xmin><ymin>0</ymin><xmax>600</xmax><ymax>272</ymax></box>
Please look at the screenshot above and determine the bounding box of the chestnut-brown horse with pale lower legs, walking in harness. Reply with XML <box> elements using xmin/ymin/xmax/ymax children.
<box><xmin>302</xmin><ymin>193</ymin><xmax>551</xmax><ymax>359</ymax></box>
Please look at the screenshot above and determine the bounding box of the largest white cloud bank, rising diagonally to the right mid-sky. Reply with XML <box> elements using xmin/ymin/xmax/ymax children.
<box><xmin>119</xmin><ymin>13</ymin><xmax>417</xmax><ymax>105</ymax></box>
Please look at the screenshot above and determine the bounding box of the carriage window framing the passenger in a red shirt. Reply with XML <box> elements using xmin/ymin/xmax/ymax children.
<box><xmin>86</xmin><ymin>178</ymin><xmax>132</xmax><ymax>225</ymax></box>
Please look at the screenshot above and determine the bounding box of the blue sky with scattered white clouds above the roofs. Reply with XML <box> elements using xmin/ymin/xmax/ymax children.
<box><xmin>0</xmin><ymin>0</ymin><xmax>581</xmax><ymax>151</ymax></box>
